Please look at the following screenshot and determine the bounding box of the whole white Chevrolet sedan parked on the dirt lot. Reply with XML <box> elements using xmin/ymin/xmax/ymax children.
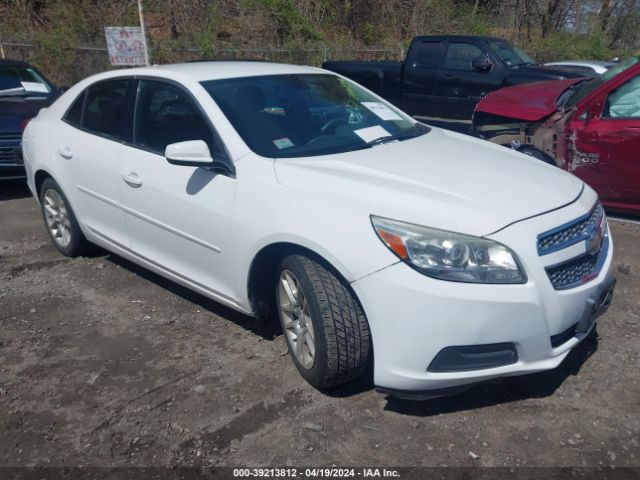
<box><xmin>24</xmin><ymin>62</ymin><xmax>615</xmax><ymax>398</ymax></box>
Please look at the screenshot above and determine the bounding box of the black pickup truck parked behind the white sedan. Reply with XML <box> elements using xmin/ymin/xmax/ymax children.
<box><xmin>322</xmin><ymin>35</ymin><xmax>584</xmax><ymax>120</ymax></box>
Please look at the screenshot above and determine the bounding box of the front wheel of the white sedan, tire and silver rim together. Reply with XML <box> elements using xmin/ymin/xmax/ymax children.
<box><xmin>276</xmin><ymin>254</ymin><xmax>371</xmax><ymax>389</ymax></box>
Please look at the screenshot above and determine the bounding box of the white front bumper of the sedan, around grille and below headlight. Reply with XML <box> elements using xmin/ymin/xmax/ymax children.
<box><xmin>352</xmin><ymin>189</ymin><xmax>613</xmax><ymax>395</ymax></box>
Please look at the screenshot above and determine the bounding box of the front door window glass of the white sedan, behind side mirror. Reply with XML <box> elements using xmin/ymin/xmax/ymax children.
<box><xmin>133</xmin><ymin>80</ymin><xmax>222</xmax><ymax>155</ymax></box>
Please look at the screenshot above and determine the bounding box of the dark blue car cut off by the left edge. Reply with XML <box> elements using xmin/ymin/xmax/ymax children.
<box><xmin>0</xmin><ymin>60</ymin><xmax>60</xmax><ymax>180</ymax></box>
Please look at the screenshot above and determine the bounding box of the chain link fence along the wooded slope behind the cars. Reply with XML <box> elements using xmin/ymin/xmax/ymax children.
<box><xmin>0</xmin><ymin>42</ymin><xmax>405</xmax><ymax>85</ymax></box>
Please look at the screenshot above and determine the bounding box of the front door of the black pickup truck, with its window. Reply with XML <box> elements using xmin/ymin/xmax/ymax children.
<box><xmin>435</xmin><ymin>40</ymin><xmax>502</xmax><ymax>120</ymax></box>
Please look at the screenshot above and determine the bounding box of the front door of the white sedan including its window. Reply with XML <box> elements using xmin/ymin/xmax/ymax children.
<box><xmin>120</xmin><ymin>79</ymin><xmax>236</xmax><ymax>299</ymax></box>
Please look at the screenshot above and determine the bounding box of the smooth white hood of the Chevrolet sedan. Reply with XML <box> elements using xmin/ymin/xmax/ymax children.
<box><xmin>275</xmin><ymin>128</ymin><xmax>583</xmax><ymax>236</ymax></box>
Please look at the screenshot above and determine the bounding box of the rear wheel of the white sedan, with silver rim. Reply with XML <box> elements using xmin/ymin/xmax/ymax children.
<box><xmin>40</xmin><ymin>178</ymin><xmax>89</xmax><ymax>257</ymax></box>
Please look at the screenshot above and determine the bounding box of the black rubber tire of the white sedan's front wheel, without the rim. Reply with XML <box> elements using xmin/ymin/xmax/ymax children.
<box><xmin>276</xmin><ymin>254</ymin><xmax>372</xmax><ymax>389</ymax></box>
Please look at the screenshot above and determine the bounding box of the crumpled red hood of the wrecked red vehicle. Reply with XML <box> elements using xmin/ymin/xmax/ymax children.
<box><xmin>476</xmin><ymin>78</ymin><xmax>582</xmax><ymax>121</ymax></box>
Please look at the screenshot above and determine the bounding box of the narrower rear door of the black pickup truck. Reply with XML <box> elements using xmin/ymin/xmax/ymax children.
<box><xmin>402</xmin><ymin>39</ymin><xmax>444</xmax><ymax>118</ymax></box>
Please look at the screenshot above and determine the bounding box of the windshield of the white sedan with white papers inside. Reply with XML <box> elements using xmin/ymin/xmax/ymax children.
<box><xmin>202</xmin><ymin>74</ymin><xmax>428</xmax><ymax>158</ymax></box>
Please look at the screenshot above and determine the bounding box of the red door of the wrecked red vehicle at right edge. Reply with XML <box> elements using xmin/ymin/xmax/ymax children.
<box><xmin>571</xmin><ymin>75</ymin><xmax>640</xmax><ymax>211</ymax></box>
